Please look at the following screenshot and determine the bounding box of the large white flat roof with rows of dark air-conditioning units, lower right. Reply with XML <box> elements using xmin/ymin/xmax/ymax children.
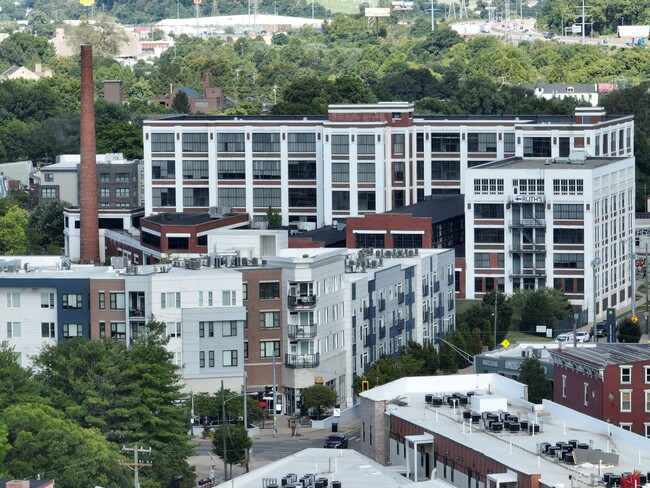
<box><xmin>361</xmin><ymin>374</ymin><xmax>650</xmax><ymax>486</ymax></box>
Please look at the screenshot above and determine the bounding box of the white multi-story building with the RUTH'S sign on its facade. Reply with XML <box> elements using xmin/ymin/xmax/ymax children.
<box><xmin>464</xmin><ymin>152</ymin><xmax>635</xmax><ymax>315</ymax></box>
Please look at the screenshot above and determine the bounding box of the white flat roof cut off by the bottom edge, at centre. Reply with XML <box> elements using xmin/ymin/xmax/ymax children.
<box><xmin>217</xmin><ymin>448</ymin><xmax>418</xmax><ymax>488</ymax></box>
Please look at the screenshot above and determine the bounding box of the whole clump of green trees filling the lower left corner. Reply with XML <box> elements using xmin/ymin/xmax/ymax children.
<box><xmin>0</xmin><ymin>320</ymin><xmax>195</xmax><ymax>488</ymax></box>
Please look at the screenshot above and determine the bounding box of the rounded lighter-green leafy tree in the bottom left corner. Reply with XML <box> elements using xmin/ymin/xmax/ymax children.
<box><xmin>0</xmin><ymin>403</ymin><xmax>131</xmax><ymax>488</ymax></box>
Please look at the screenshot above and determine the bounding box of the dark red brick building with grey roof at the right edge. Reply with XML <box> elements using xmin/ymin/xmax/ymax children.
<box><xmin>549</xmin><ymin>344</ymin><xmax>650</xmax><ymax>437</ymax></box>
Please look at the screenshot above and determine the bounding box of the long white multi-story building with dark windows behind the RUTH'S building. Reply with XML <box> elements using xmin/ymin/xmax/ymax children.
<box><xmin>144</xmin><ymin>102</ymin><xmax>634</xmax><ymax>226</ymax></box>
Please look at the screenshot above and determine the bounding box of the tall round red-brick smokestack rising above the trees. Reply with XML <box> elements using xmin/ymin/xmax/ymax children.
<box><xmin>79</xmin><ymin>44</ymin><xmax>99</xmax><ymax>263</ymax></box>
